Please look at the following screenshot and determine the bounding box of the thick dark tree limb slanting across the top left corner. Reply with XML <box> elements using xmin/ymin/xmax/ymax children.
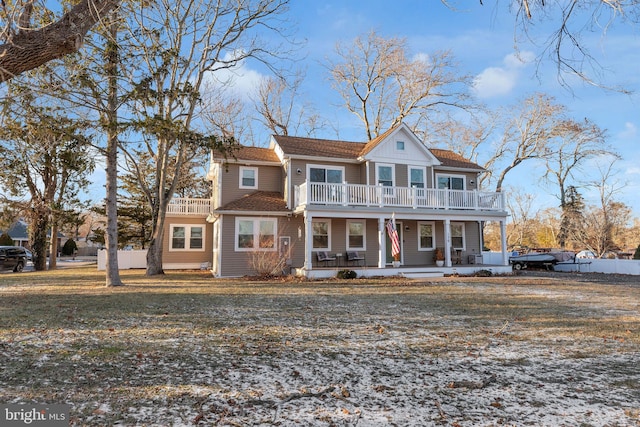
<box><xmin>0</xmin><ymin>0</ymin><xmax>119</xmax><ymax>82</ymax></box>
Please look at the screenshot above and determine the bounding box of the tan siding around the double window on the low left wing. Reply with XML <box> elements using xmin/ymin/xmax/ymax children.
<box><xmin>162</xmin><ymin>216</ymin><xmax>213</xmax><ymax>264</ymax></box>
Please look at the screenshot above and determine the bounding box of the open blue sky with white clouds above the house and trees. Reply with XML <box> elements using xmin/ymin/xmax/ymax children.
<box><xmin>77</xmin><ymin>0</ymin><xmax>640</xmax><ymax>217</ymax></box>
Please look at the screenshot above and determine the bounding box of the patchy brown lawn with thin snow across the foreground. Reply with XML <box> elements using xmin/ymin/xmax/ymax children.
<box><xmin>0</xmin><ymin>272</ymin><xmax>640</xmax><ymax>426</ymax></box>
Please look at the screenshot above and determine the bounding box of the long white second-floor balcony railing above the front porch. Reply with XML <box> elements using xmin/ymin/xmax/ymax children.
<box><xmin>295</xmin><ymin>182</ymin><xmax>505</xmax><ymax>211</ymax></box>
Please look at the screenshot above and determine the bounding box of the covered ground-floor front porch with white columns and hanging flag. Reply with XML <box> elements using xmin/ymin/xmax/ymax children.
<box><xmin>291</xmin><ymin>208</ymin><xmax>511</xmax><ymax>278</ymax></box>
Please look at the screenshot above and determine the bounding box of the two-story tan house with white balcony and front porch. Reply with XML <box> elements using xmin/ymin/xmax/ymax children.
<box><xmin>163</xmin><ymin>124</ymin><xmax>510</xmax><ymax>277</ymax></box>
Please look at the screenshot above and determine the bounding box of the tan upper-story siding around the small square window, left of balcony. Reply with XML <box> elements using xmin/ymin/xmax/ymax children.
<box><xmin>219</xmin><ymin>163</ymin><xmax>283</xmax><ymax>206</ymax></box>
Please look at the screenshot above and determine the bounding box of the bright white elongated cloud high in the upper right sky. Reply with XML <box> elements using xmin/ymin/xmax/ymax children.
<box><xmin>473</xmin><ymin>51</ymin><xmax>534</xmax><ymax>98</ymax></box>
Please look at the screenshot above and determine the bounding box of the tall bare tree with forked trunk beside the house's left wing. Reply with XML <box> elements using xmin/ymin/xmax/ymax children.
<box><xmin>125</xmin><ymin>0</ymin><xmax>288</xmax><ymax>275</ymax></box>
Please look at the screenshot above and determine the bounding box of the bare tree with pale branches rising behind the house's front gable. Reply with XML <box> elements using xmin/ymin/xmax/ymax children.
<box><xmin>327</xmin><ymin>31</ymin><xmax>470</xmax><ymax>140</ymax></box>
